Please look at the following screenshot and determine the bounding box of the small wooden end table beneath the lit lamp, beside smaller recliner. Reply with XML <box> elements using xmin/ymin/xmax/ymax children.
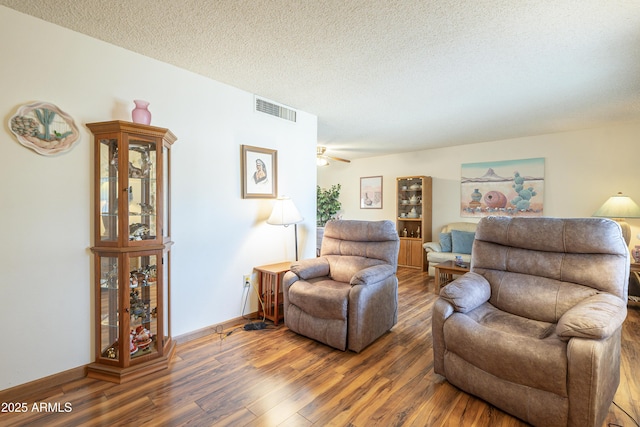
<box><xmin>253</xmin><ymin>261</ymin><xmax>291</xmax><ymax>326</ymax></box>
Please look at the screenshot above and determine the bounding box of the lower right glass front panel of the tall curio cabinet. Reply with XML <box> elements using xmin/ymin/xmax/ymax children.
<box><xmin>129</xmin><ymin>254</ymin><xmax>162</xmax><ymax>361</ymax></box>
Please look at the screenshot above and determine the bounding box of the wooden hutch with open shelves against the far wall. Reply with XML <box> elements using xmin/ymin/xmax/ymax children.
<box><xmin>396</xmin><ymin>176</ymin><xmax>431</xmax><ymax>271</ymax></box>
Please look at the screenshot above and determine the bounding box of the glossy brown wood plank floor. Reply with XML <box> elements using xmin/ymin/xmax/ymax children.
<box><xmin>0</xmin><ymin>269</ymin><xmax>640</xmax><ymax>427</ymax></box>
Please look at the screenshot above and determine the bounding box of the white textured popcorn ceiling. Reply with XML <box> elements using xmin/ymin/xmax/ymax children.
<box><xmin>0</xmin><ymin>0</ymin><xmax>640</xmax><ymax>159</ymax></box>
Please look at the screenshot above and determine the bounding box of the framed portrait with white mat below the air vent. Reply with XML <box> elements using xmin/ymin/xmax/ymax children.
<box><xmin>240</xmin><ymin>145</ymin><xmax>278</xmax><ymax>199</ymax></box>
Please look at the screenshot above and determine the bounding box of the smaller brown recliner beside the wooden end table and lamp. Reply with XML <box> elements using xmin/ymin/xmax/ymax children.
<box><xmin>283</xmin><ymin>221</ymin><xmax>400</xmax><ymax>352</ymax></box>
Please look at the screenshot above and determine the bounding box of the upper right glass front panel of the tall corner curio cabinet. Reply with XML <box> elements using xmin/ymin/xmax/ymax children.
<box><xmin>124</xmin><ymin>136</ymin><xmax>158</xmax><ymax>241</ymax></box>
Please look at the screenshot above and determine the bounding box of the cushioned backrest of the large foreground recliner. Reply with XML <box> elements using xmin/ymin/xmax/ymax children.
<box><xmin>471</xmin><ymin>217</ymin><xmax>629</xmax><ymax>322</ymax></box>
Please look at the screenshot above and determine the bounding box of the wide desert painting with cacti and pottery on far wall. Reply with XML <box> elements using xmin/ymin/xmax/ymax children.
<box><xmin>460</xmin><ymin>158</ymin><xmax>544</xmax><ymax>218</ymax></box>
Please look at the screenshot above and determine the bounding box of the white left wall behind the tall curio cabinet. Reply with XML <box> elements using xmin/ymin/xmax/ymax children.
<box><xmin>0</xmin><ymin>6</ymin><xmax>317</xmax><ymax>389</ymax></box>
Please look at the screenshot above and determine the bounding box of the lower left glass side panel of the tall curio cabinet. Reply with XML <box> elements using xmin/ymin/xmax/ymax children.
<box><xmin>96</xmin><ymin>256</ymin><xmax>121</xmax><ymax>360</ymax></box>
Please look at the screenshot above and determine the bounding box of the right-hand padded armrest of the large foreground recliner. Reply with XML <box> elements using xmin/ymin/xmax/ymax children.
<box><xmin>556</xmin><ymin>294</ymin><xmax>627</xmax><ymax>340</ymax></box>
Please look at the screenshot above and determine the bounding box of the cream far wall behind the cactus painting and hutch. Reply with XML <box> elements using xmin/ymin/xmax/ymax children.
<box><xmin>318</xmin><ymin>122</ymin><xmax>640</xmax><ymax>247</ymax></box>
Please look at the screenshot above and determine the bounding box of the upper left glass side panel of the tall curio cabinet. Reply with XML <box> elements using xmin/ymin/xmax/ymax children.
<box><xmin>96</xmin><ymin>138</ymin><xmax>119</xmax><ymax>242</ymax></box>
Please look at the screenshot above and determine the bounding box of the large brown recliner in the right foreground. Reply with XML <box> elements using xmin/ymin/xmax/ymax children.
<box><xmin>432</xmin><ymin>217</ymin><xmax>629</xmax><ymax>427</ymax></box>
